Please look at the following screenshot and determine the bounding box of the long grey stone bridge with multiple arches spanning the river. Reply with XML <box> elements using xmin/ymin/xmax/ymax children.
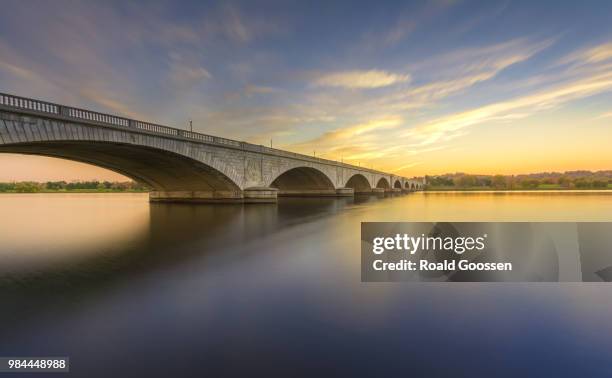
<box><xmin>0</xmin><ymin>93</ymin><xmax>423</xmax><ymax>202</ymax></box>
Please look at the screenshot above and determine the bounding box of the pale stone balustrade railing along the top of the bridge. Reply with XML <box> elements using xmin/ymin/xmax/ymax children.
<box><xmin>0</xmin><ymin>93</ymin><xmax>383</xmax><ymax>173</ymax></box>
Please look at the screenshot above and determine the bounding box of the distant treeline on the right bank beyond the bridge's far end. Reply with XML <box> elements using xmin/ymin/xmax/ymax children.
<box><xmin>426</xmin><ymin>171</ymin><xmax>612</xmax><ymax>190</ymax></box>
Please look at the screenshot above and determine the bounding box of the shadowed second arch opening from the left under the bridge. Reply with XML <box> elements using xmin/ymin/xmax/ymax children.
<box><xmin>270</xmin><ymin>166</ymin><xmax>336</xmax><ymax>196</ymax></box>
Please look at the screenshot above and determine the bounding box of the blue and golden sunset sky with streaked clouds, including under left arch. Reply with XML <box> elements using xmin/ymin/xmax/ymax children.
<box><xmin>0</xmin><ymin>0</ymin><xmax>612</xmax><ymax>181</ymax></box>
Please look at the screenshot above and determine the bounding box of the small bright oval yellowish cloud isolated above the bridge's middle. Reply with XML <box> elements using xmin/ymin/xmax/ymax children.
<box><xmin>314</xmin><ymin>70</ymin><xmax>410</xmax><ymax>89</ymax></box>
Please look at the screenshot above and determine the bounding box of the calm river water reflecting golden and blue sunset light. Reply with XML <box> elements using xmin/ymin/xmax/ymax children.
<box><xmin>0</xmin><ymin>193</ymin><xmax>612</xmax><ymax>377</ymax></box>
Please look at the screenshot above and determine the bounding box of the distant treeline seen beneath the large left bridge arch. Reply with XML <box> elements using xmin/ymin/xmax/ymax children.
<box><xmin>0</xmin><ymin>181</ymin><xmax>149</xmax><ymax>193</ymax></box>
